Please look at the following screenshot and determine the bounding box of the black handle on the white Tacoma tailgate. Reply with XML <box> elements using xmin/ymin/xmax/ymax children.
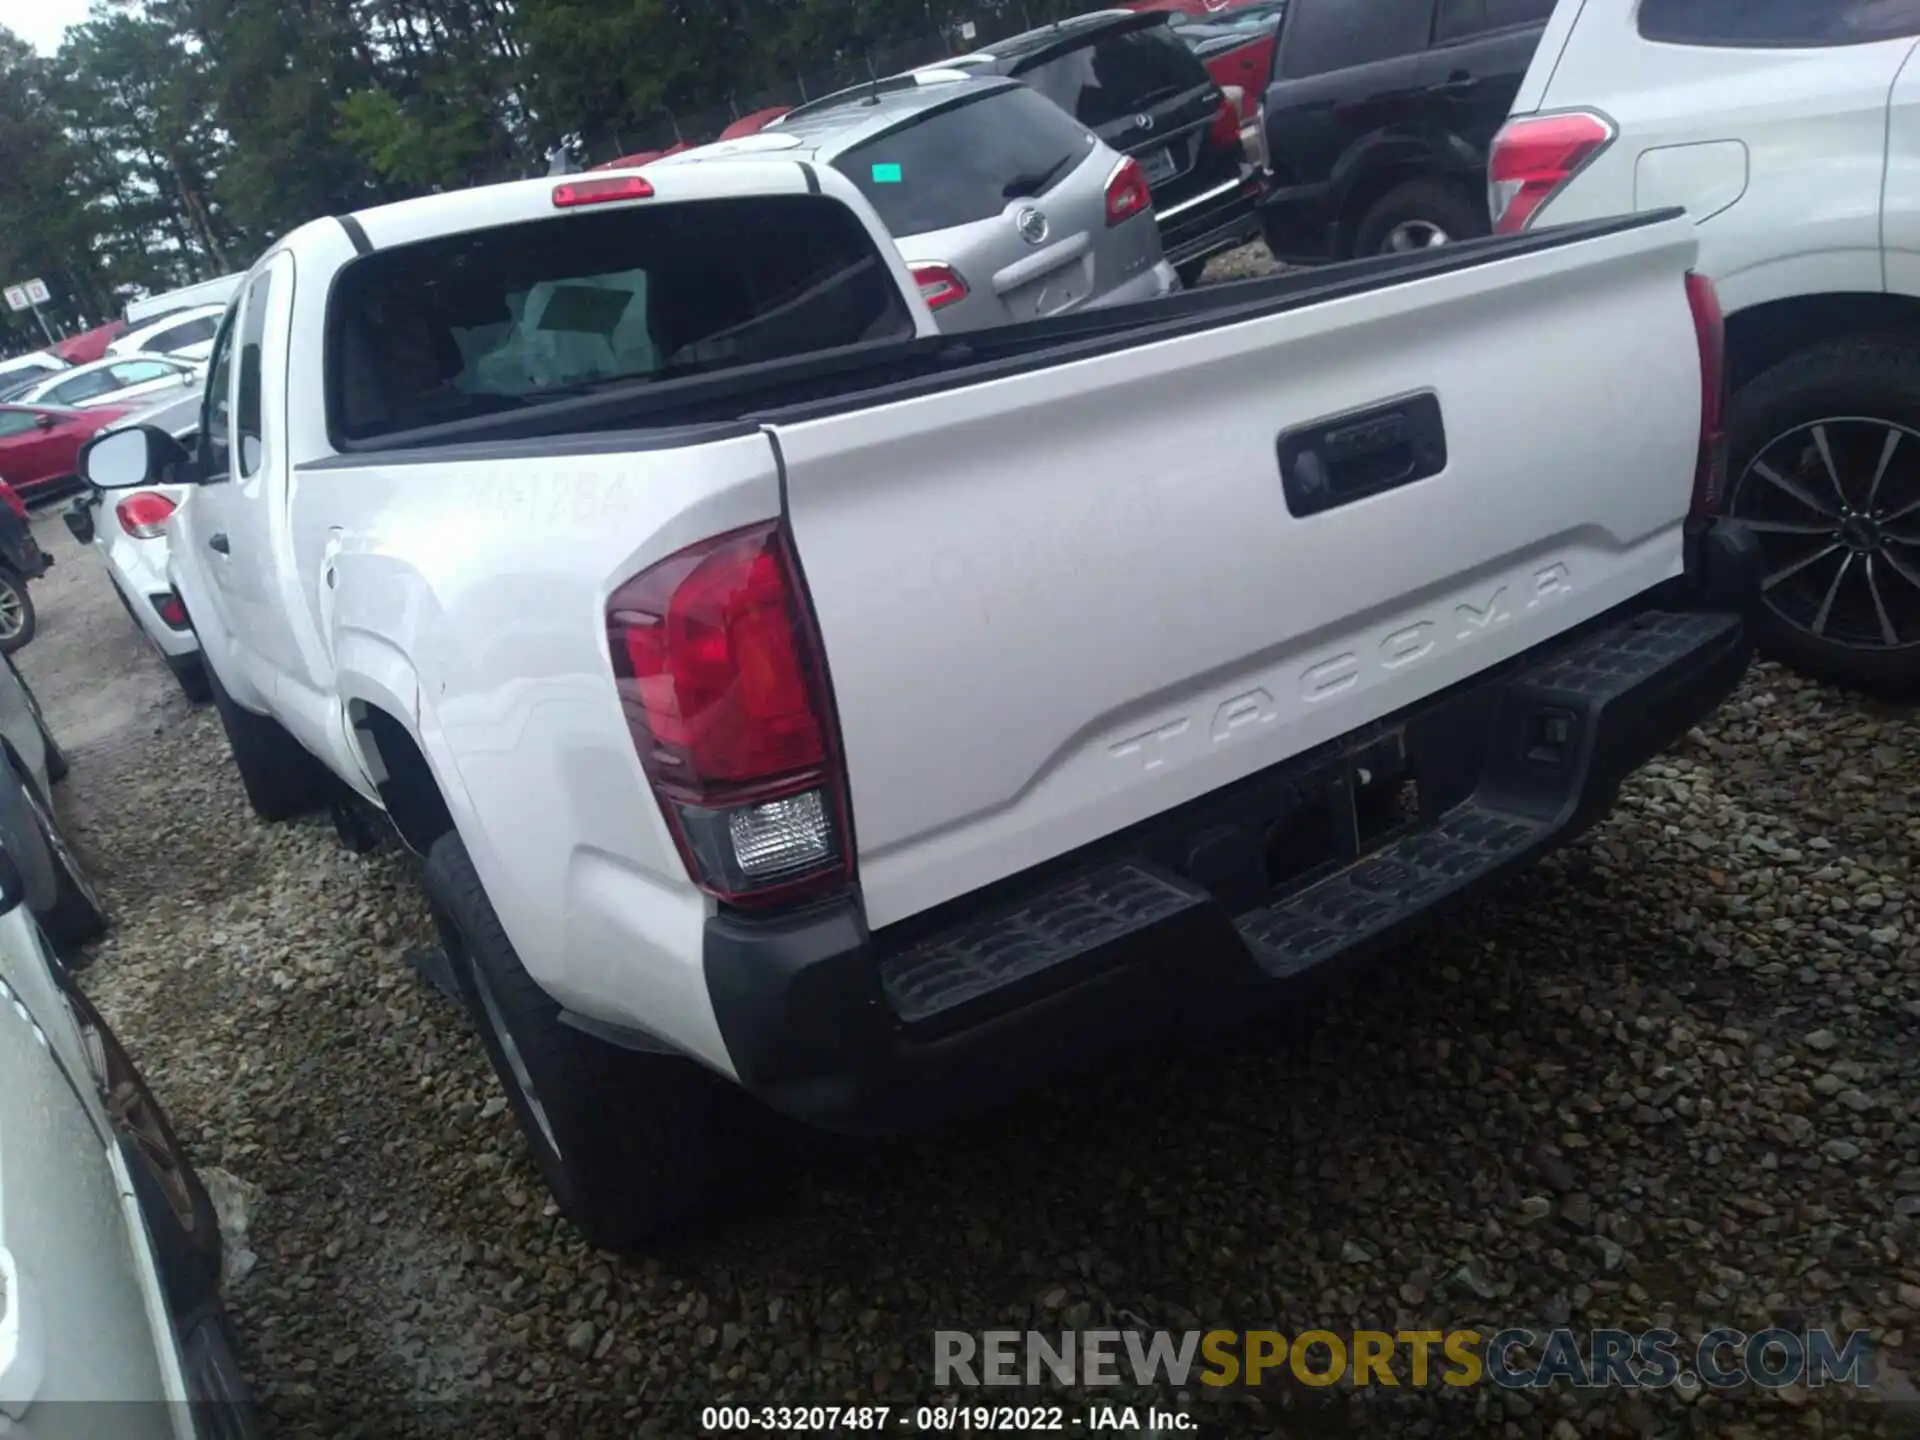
<box><xmin>1279</xmin><ymin>390</ymin><xmax>1446</xmax><ymax>516</ymax></box>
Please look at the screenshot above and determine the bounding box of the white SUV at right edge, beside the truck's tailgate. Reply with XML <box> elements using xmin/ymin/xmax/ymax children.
<box><xmin>1488</xmin><ymin>0</ymin><xmax>1920</xmax><ymax>691</ymax></box>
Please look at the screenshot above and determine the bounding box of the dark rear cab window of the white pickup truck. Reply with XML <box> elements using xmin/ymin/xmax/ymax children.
<box><xmin>326</xmin><ymin>196</ymin><xmax>914</xmax><ymax>447</ymax></box>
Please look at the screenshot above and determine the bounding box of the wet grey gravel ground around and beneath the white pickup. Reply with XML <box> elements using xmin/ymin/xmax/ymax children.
<box><xmin>21</xmin><ymin>408</ymin><xmax>1920</xmax><ymax>1440</ymax></box>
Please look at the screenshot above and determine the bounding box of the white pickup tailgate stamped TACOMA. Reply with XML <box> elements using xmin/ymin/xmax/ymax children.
<box><xmin>770</xmin><ymin>219</ymin><xmax>1699</xmax><ymax>929</ymax></box>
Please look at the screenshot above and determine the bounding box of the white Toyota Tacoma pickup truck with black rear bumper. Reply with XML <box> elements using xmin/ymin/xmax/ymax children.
<box><xmin>84</xmin><ymin>157</ymin><xmax>1753</xmax><ymax>1246</ymax></box>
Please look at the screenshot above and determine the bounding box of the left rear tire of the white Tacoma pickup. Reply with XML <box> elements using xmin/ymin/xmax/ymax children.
<box><xmin>426</xmin><ymin>833</ymin><xmax>760</xmax><ymax>1250</ymax></box>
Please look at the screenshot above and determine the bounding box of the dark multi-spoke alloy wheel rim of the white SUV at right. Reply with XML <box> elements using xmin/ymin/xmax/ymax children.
<box><xmin>1728</xmin><ymin>415</ymin><xmax>1920</xmax><ymax>651</ymax></box>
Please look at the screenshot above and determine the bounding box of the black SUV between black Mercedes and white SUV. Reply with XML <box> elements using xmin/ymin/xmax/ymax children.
<box><xmin>1261</xmin><ymin>0</ymin><xmax>1553</xmax><ymax>263</ymax></box>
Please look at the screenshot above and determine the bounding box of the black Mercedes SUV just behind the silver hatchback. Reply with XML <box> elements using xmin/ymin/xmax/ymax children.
<box><xmin>962</xmin><ymin>10</ymin><xmax>1261</xmax><ymax>284</ymax></box>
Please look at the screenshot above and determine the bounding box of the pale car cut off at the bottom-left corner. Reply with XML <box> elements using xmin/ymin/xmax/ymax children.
<box><xmin>0</xmin><ymin>794</ymin><xmax>253</xmax><ymax>1440</ymax></box>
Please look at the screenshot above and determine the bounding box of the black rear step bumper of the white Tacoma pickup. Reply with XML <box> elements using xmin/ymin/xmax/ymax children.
<box><xmin>705</xmin><ymin>524</ymin><xmax>1757</xmax><ymax>1133</ymax></box>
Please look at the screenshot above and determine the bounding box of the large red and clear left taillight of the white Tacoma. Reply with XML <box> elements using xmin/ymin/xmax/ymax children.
<box><xmin>607</xmin><ymin>524</ymin><xmax>852</xmax><ymax>904</ymax></box>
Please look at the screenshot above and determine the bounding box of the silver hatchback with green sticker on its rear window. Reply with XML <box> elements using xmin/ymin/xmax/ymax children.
<box><xmin>679</xmin><ymin>71</ymin><xmax>1179</xmax><ymax>332</ymax></box>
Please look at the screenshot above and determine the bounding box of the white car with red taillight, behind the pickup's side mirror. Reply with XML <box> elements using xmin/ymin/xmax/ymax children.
<box><xmin>61</xmin><ymin>394</ymin><xmax>207</xmax><ymax>703</ymax></box>
